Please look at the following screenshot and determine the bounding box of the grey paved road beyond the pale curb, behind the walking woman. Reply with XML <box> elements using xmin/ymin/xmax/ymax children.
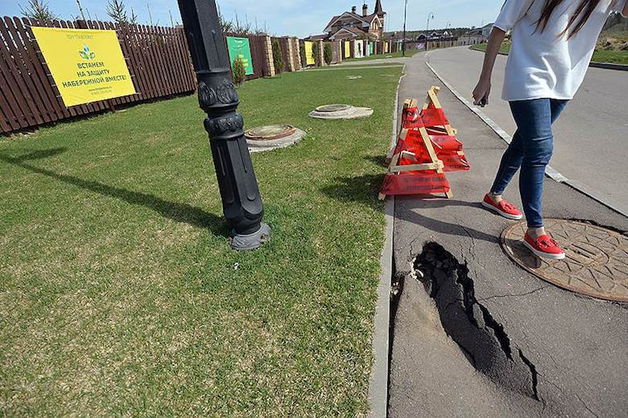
<box><xmin>427</xmin><ymin>47</ymin><xmax>628</xmax><ymax>212</ymax></box>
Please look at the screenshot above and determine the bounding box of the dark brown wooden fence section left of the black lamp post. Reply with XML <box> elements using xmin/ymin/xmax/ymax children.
<box><xmin>0</xmin><ymin>16</ymin><xmax>195</xmax><ymax>133</ymax></box>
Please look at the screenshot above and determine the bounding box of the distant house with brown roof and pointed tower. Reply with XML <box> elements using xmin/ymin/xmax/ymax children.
<box><xmin>324</xmin><ymin>0</ymin><xmax>386</xmax><ymax>41</ymax></box>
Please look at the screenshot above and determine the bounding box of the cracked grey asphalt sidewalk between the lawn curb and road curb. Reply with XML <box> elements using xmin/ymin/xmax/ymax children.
<box><xmin>389</xmin><ymin>54</ymin><xmax>628</xmax><ymax>417</ymax></box>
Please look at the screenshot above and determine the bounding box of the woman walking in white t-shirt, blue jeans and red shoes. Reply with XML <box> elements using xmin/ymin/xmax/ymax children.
<box><xmin>473</xmin><ymin>0</ymin><xmax>628</xmax><ymax>259</ymax></box>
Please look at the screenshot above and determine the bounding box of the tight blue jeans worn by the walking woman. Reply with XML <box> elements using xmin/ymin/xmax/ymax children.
<box><xmin>491</xmin><ymin>99</ymin><xmax>568</xmax><ymax>228</ymax></box>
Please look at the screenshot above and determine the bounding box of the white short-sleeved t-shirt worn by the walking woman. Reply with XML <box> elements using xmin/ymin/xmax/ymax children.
<box><xmin>494</xmin><ymin>0</ymin><xmax>628</xmax><ymax>101</ymax></box>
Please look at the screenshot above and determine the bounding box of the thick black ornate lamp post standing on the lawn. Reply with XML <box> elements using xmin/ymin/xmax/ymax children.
<box><xmin>178</xmin><ymin>0</ymin><xmax>270</xmax><ymax>250</ymax></box>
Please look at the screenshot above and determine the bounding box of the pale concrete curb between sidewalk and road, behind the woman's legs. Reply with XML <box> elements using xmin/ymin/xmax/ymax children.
<box><xmin>425</xmin><ymin>61</ymin><xmax>628</xmax><ymax>222</ymax></box>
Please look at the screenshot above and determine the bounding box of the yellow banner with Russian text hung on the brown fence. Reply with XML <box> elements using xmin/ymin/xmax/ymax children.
<box><xmin>32</xmin><ymin>26</ymin><xmax>135</xmax><ymax>107</ymax></box>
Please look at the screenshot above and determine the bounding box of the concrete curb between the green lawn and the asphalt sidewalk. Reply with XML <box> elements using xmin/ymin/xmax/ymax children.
<box><xmin>367</xmin><ymin>65</ymin><xmax>406</xmax><ymax>418</ymax></box>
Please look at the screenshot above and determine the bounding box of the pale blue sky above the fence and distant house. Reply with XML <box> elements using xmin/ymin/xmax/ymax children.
<box><xmin>0</xmin><ymin>0</ymin><xmax>504</xmax><ymax>37</ymax></box>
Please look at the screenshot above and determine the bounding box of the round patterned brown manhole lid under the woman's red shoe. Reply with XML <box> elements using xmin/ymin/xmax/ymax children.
<box><xmin>502</xmin><ymin>219</ymin><xmax>628</xmax><ymax>302</ymax></box>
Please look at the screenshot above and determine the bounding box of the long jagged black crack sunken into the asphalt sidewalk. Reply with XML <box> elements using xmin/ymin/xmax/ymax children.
<box><xmin>414</xmin><ymin>243</ymin><xmax>543</xmax><ymax>402</ymax></box>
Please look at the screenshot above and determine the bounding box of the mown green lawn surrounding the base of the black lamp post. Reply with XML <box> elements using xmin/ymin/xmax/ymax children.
<box><xmin>0</xmin><ymin>64</ymin><xmax>401</xmax><ymax>417</ymax></box>
